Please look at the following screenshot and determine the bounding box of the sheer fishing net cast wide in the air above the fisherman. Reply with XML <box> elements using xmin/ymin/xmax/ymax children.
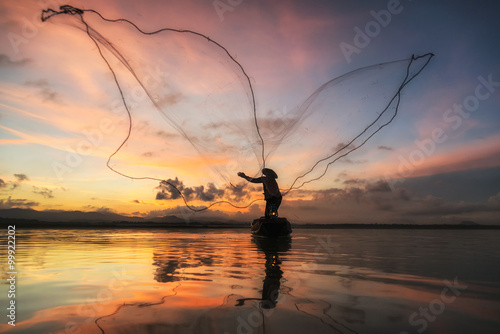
<box><xmin>42</xmin><ymin>6</ymin><xmax>432</xmax><ymax>211</ymax></box>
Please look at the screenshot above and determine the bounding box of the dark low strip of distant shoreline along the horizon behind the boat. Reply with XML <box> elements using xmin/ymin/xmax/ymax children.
<box><xmin>0</xmin><ymin>218</ymin><xmax>500</xmax><ymax>230</ymax></box>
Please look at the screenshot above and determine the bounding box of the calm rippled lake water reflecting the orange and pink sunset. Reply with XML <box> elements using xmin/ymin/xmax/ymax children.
<box><xmin>0</xmin><ymin>227</ymin><xmax>500</xmax><ymax>334</ymax></box>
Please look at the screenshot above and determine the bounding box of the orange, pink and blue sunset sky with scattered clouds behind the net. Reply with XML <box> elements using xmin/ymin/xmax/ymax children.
<box><xmin>0</xmin><ymin>0</ymin><xmax>500</xmax><ymax>224</ymax></box>
